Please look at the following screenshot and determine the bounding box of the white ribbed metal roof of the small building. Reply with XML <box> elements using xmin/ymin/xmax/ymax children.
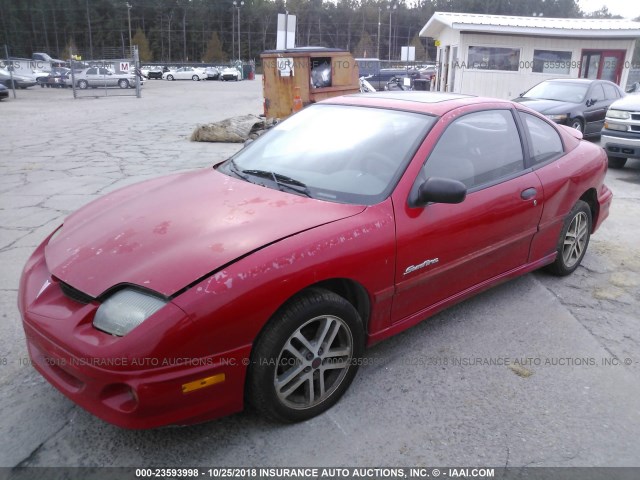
<box><xmin>420</xmin><ymin>12</ymin><xmax>640</xmax><ymax>38</ymax></box>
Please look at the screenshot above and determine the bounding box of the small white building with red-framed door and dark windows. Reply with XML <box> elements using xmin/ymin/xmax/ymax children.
<box><xmin>420</xmin><ymin>12</ymin><xmax>640</xmax><ymax>99</ymax></box>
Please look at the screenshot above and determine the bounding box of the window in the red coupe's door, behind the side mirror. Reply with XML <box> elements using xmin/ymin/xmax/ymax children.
<box><xmin>422</xmin><ymin>110</ymin><xmax>524</xmax><ymax>189</ymax></box>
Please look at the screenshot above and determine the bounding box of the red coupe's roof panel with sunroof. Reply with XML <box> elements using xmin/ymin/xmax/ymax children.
<box><xmin>320</xmin><ymin>91</ymin><xmax>515</xmax><ymax>116</ymax></box>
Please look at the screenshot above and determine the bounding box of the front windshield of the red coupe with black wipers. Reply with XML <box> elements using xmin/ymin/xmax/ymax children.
<box><xmin>220</xmin><ymin>105</ymin><xmax>435</xmax><ymax>205</ymax></box>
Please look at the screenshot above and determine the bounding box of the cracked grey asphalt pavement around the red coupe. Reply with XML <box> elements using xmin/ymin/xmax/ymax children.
<box><xmin>0</xmin><ymin>78</ymin><xmax>640</xmax><ymax>467</ymax></box>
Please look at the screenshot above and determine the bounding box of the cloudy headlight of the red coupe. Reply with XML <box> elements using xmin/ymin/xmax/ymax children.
<box><xmin>93</xmin><ymin>288</ymin><xmax>167</xmax><ymax>337</ymax></box>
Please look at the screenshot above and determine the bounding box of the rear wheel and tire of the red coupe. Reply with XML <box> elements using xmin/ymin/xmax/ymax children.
<box><xmin>547</xmin><ymin>200</ymin><xmax>592</xmax><ymax>277</ymax></box>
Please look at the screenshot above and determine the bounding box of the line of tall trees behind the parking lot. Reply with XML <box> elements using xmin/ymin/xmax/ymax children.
<box><xmin>0</xmin><ymin>0</ymin><xmax>632</xmax><ymax>63</ymax></box>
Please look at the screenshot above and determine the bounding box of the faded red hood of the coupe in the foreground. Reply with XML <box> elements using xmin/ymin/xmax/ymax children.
<box><xmin>45</xmin><ymin>169</ymin><xmax>365</xmax><ymax>297</ymax></box>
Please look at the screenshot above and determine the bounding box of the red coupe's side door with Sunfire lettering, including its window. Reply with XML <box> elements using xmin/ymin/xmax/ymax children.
<box><xmin>392</xmin><ymin>108</ymin><xmax>543</xmax><ymax>322</ymax></box>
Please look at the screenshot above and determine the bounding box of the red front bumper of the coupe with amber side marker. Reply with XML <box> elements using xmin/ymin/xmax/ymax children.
<box><xmin>18</xmin><ymin>239</ymin><xmax>251</xmax><ymax>429</ymax></box>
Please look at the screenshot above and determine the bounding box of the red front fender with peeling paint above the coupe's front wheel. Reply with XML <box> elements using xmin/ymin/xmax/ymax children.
<box><xmin>167</xmin><ymin>199</ymin><xmax>395</xmax><ymax>357</ymax></box>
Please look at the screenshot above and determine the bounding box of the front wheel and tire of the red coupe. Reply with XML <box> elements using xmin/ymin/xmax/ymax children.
<box><xmin>246</xmin><ymin>289</ymin><xmax>364</xmax><ymax>422</ymax></box>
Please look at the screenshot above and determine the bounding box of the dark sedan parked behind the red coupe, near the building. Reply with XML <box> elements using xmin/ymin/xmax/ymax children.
<box><xmin>514</xmin><ymin>78</ymin><xmax>625</xmax><ymax>137</ymax></box>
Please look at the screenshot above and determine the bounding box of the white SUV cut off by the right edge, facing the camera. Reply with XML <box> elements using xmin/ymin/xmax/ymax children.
<box><xmin>600</xmin><ymin>94</ymin><xmax>640</xmax><ymax>168</ymax></box>
